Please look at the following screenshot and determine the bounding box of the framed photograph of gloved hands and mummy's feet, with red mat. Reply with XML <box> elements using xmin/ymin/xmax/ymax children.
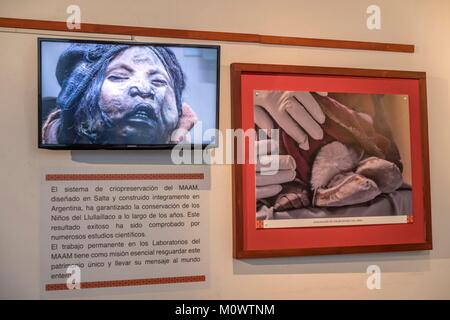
<box><xmin>231</xmin><ymin>63</ymin><xmax>432</xmax><ymax>259</ymax></box>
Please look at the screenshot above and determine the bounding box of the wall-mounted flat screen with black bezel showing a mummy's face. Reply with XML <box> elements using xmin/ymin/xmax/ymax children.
<box><xmin>38</xmin><ymin>38</ymin><xmax>220</xmax><ymax>149</ymax></box>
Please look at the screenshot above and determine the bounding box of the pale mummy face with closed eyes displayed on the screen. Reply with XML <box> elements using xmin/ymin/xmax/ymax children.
<box><xmin>98</xmin><ymin>47</ymin><xmax>179</xmax><ymax>144</ymax></box>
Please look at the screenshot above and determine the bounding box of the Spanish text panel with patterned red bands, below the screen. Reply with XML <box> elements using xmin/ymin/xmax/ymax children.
<box><xmin>41</xmin><ymin>166</ymin><xmax>209</xmax><ymax>296</ymax></box>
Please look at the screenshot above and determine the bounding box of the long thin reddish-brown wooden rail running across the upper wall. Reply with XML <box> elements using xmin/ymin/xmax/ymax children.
<box><xmin>0</xmin><ymin>17</ymin><xmax>414</xmax><ymax>53</ymax></box>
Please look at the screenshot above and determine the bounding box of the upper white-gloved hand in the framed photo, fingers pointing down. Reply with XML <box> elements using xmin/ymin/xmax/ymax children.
<box><xmin>254</xmin><ymin>90</ymin><xmax>326</xmax><ymax>150</ymax></box>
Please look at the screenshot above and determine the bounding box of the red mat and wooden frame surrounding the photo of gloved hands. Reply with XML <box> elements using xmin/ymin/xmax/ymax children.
<box><xmin>231</xmin><ymin>63</ymin><xmax>432</xmax><ymax>259</ymax></box>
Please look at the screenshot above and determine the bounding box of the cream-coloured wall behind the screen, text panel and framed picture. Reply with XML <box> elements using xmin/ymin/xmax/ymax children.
<box><xmin>0</xmin><ymin>0</ymin><xmax>450</xmax><ymax>299</ymax></box>
